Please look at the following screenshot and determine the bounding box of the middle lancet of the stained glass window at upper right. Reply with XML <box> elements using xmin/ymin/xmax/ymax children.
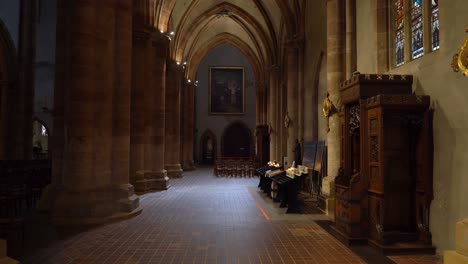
<box><xmin>411</xmin><ymin>0</ymin><xmax>424</xmax><ymax>59</ymax></box>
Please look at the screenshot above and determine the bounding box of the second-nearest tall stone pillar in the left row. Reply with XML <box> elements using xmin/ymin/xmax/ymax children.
<box><xmin>130</xmin><ymin>0</ymin><xmax>169</xmax><ymax>192</ymax></box>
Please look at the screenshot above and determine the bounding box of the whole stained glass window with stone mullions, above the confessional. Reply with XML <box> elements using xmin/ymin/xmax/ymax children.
<box><xmin>390</xmin><ymin>0</ymin><xmax>440</xmax><ymax>67</ymax></box>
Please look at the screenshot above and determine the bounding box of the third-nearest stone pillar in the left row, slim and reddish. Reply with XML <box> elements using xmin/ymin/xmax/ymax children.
<box><xmin>164</xmin><ymin>61</ymin><xmax>183</xmax><ymax>178</ymax></box>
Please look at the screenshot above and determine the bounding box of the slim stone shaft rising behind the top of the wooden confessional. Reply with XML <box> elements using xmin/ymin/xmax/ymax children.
<box><xmin>346</xmin><ymin>0</ymin><xmax>357</xmax><ymax>80</ymax></box>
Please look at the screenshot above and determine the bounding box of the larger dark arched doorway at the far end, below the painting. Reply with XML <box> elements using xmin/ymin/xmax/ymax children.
<box><xmin>221</xmin><ymin>121</ymin><xmax>253</xmax><ymax>158</ymax></box>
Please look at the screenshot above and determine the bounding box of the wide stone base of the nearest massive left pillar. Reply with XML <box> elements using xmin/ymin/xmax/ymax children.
<box><xmin>37</xmin><ymin>184</ymin><xmax>142</xmax><ymax>225</ymax></box>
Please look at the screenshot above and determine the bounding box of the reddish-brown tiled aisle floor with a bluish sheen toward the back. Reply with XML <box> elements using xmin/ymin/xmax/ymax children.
<box><xmin>22</xmin><ymin>168</ymin><xmax>438</xmax><ymax>264</ymax></box>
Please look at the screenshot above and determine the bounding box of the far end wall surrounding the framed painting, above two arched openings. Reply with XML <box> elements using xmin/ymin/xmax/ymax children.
<box><xmin>194</xmin><ymin>44</ymin><xmax>256</xmax><ymax>161</ymax></box>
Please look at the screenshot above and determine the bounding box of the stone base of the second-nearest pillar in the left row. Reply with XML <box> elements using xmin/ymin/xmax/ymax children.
<box><xmin>130</xmin><ymin>170</ymin><xmax>170</xmax><ymax>192</ymax></box>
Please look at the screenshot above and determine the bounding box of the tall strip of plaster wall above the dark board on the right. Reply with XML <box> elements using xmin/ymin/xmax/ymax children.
<box><xmin>303</xmin><ymin>0</ymin><xmax>327</xmax><ymax>141</ymax></box>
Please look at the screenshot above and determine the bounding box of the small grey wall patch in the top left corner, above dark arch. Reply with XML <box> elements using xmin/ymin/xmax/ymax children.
<box><xmin>0</xmin><ymin>0</ymin><xmax>20</xmax><ymax>48</ymax></box>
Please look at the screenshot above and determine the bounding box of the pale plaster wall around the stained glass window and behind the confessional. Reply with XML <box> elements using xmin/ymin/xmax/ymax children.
<box><xmin>356</xmin><ymin>0</ymin><xmax>468</xmax><ymax>254</ymax></box>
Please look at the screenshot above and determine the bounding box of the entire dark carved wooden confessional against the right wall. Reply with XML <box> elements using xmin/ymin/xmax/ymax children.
<box><xmin>333</xmin><ymin>74</ymin><xmax>435</xmax><ymax>254</ymax></box>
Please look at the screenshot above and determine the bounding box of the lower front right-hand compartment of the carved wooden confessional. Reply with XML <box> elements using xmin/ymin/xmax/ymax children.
<box><xmin>366</xmin><ymin>95</ymin><xmax>432</xmax><ymax>249</ymax></box>
